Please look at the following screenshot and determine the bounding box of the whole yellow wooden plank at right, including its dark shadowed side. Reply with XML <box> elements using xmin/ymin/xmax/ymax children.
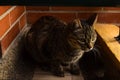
<box><xmin>95</xmin><ymin>24</ymin><xmax>120</xmax><ymax>67</ymax></box>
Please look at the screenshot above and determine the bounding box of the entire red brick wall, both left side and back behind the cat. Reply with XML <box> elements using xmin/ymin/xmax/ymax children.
<box><xmin>0</xmin><ymin>6</ymin><xmax>120</xmax><ymax>55</ymax></box>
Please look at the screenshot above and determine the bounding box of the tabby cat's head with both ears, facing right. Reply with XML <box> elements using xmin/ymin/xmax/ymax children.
<box><xmin>68</xmin><ymin>14</ymin><xmax>97</xmax><ymax>52</ymax></box>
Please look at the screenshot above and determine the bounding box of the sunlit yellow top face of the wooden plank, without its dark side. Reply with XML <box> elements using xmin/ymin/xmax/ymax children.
<box><xmin>95</xmin><ymin>24</ymin><xmax>120</xmax><ymax>62</ymax></box>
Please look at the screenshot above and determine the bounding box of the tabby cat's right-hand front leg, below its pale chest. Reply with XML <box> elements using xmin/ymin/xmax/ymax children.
<box><xmin>70</xmin><ymin>63</ymin><xmax>80</xmax><ymax>75</ymax></box>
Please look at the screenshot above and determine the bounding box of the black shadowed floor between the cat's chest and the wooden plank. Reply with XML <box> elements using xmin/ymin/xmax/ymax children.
<box><xmin>80</xmin><ymin>45</ymin><xmax>120</xmax><ymax>80</ymax></box>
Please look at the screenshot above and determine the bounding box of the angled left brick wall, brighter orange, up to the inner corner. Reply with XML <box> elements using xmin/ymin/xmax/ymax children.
<box><xmin>0</xmin><ymin>6</ymin><xmax>26</xmax><ymax>53</ymax></box>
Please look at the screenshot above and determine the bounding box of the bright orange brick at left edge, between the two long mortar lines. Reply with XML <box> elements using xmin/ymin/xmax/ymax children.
<box><xmin>0</xmin><ymin>14</ymin><xmax>10</xmax><ymax>37</ymax></box>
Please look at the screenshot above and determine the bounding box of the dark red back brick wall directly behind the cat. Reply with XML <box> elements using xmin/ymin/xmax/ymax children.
<box><xmin>26</xmin><ymin>6</ymin><xmax>120</xmax><ymax>24</ymax></box>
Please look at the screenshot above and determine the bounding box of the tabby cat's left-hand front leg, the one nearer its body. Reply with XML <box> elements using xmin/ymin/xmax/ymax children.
<box><xmin>51</xmin><ymin>61</ymin><xmax>65</xmax><ymax>77</ymax></box>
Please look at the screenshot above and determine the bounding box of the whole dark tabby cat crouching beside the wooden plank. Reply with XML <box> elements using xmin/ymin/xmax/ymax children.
<box><xmin>24</xmin><ymin>14</ymin><xmax>97</xmax><ymax>77</ymax></box>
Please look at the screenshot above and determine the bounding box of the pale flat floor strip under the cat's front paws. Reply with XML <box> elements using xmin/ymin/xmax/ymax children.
<box><xmin>33</xmin><ymin>67</ymin><xmax>84</xmax><ymax>80</ymax></box>
